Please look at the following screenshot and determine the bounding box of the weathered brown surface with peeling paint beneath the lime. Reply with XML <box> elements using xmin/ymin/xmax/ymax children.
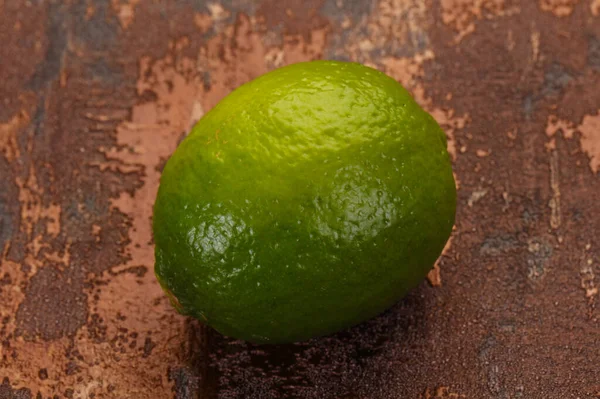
<box><xmin>0</xmin><ymin>0</ymin><xmax>600</xmax><ymax>399</ymax></box>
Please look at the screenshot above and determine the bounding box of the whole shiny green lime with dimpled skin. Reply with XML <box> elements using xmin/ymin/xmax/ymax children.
<box><xmin>153</xmin><ymin>61</ymin><xmax>456</xmax><ymax>343</ymax></box>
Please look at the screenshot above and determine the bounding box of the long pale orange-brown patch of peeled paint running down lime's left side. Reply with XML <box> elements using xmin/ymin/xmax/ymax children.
<box><xmin>85</xmin><ymin>40</ymin><xmax>202</xmax><ymax>397</ymax></box>
